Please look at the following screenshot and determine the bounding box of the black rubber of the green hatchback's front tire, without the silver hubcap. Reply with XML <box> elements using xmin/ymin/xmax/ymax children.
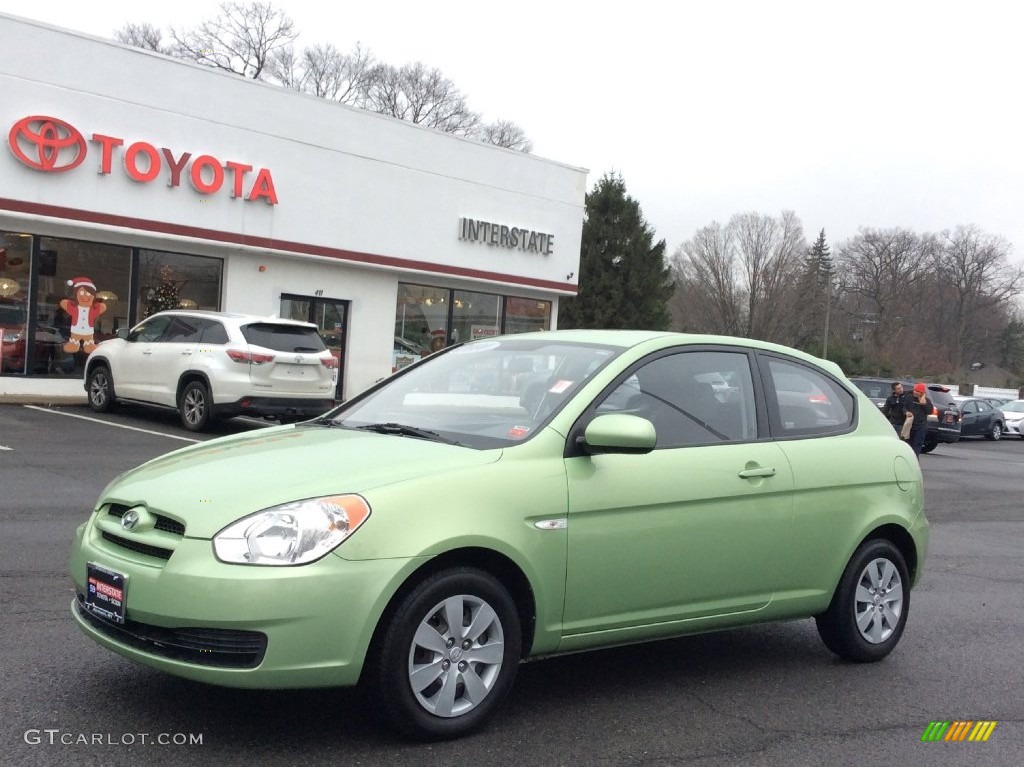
<box><xmin>367</xmin><ymin>567</ymin><xmax>522</xmax><ymax>741</ymax></box>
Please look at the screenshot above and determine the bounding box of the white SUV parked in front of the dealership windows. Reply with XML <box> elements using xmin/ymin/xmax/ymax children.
<box><xmin>85</xmin><ymin>309</ymin><xmax>338</xmax><ymax>432</ymax></box>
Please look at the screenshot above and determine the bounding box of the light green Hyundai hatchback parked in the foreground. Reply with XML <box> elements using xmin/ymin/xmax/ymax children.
<box><xmin>71</xmin><ymin>331</ymin><xmax>928</xmax><ymax>739</ymax></box>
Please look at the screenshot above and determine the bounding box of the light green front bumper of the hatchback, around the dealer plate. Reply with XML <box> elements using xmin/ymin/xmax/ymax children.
<box><xmin>70</xmin><ymin>523</ymin><xmax>419</xmax><ymax>688</ymax></box>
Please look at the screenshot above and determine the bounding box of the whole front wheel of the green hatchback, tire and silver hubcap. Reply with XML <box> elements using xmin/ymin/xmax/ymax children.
<box><xmin>368</xmin><ymin>567</ymin><xmax>522</xmax><ymax>740</ymax></box>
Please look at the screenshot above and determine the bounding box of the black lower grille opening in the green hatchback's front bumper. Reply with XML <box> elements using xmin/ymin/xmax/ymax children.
<box><xmin>75</xmin><ymin>594</ymin><xmax>266</xmax><ymax>669</ymax></box>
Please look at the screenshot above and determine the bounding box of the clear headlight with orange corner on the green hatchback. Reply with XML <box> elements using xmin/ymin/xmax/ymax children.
<box><xmin>213</xmin><ymin>494</ymin><xmax>370</xmax><ymax>565</ymax></box>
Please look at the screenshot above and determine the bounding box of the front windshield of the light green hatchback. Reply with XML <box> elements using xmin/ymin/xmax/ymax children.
<box><xmin>321</xmin><ymin>337</ymin><xmax>622</xmax><ymax>449</ymax></box>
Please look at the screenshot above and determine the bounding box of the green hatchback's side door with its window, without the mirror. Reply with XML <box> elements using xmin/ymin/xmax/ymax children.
<box><xmin>560</xmin><ymin>349</ymin><xmax>793</xmax><ymax>649</ymax></box>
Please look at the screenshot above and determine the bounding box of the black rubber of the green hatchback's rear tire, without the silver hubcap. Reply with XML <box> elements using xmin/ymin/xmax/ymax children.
<box><xmin>817</xmin><ymin>539</ymin><xmax>910</xmax><ymax>663</ymax></box>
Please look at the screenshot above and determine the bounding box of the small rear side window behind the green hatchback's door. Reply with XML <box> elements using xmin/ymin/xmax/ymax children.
<box><xmin>762</xmin><ymin>357</ymin><xmax>854</xmax><ymax>437</ymax></box>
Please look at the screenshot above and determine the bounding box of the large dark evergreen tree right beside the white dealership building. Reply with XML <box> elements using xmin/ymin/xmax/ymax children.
<box><xmin>558</xmin><ymin>174</ymin><xmax>674</xmax><ymax>330</ymax></box>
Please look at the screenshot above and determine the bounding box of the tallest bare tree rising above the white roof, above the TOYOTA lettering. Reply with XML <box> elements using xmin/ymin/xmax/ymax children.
<box><xmin>171</xmin><ymin>2</ymin><xmax>298</xmax><ymax>80</ymax></box>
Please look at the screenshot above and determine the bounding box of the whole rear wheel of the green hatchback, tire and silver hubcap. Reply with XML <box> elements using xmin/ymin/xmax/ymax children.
<box><xmin>815</xmin><ymin>539</ymin><xmax>910</xmax><ymax>663</ymax></box>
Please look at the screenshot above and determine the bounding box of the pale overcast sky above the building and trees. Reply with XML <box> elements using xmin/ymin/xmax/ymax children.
<box><xmin>8</xmin><ymin>0</ymin><xmax>1024</xmax><ymax>260</ymax></box>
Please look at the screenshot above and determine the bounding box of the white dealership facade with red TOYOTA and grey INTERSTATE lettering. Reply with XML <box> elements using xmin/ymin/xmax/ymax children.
<box><xmin>0</xmin><ymin>14</ymin><xmax>587</xmax><ymax>396</ymax></box>
